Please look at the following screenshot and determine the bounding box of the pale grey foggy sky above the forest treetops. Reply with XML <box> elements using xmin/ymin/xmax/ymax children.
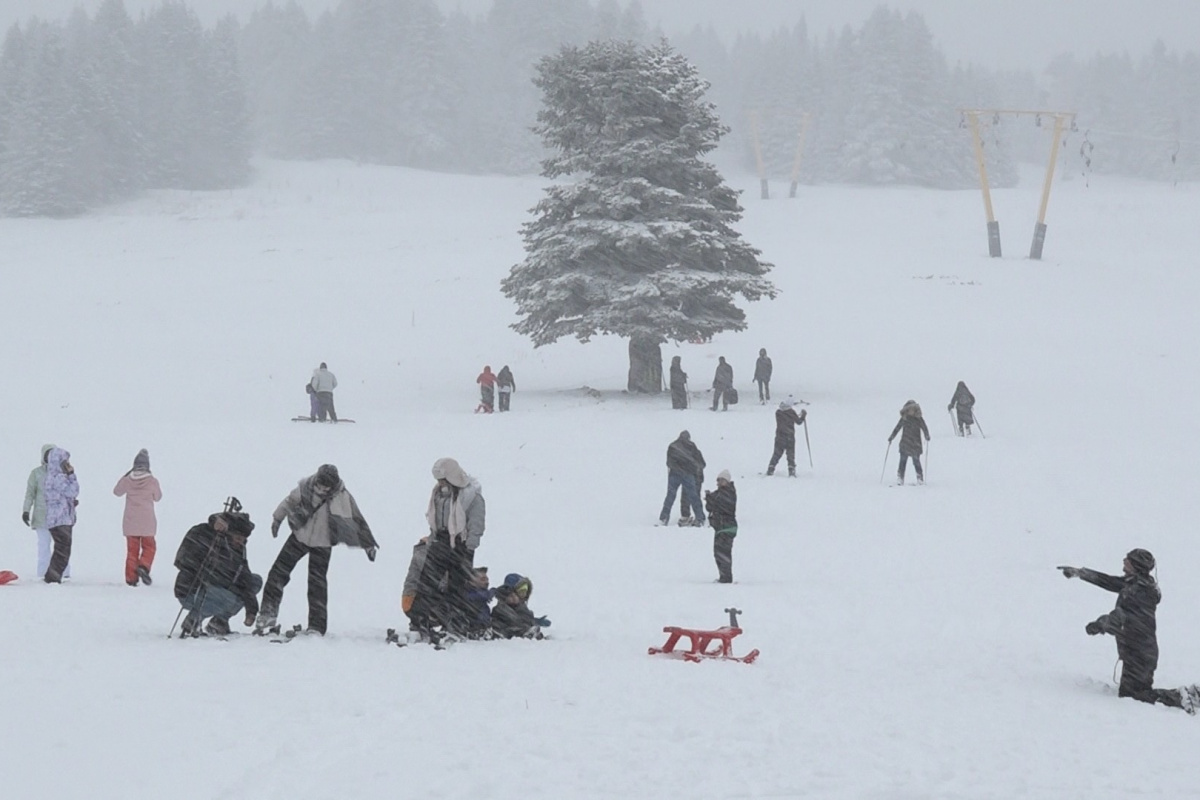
<box><xmin>0</xmin><ymin>0</ymin><xmax>1200</xmax><ymax>71</ymax></box>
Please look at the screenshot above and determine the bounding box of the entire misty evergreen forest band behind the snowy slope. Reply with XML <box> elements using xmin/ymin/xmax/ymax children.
<box><xmin>0</xmin><ymin>0</ymin><xmax>1200</xmax><ymax>215</ymax></box>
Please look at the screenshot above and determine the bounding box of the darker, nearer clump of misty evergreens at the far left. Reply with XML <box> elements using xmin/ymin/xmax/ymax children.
<box><xmin>0</xmin><ymin>0</ymin><xmax>252</xmax><ymax>216</ymax></box>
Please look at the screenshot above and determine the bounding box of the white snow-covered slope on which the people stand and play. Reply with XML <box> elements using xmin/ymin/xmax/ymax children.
<box><xmin>0</xmin><ymin>163</ymin><xmax>1200</xmax><ymax>800</ymax></box>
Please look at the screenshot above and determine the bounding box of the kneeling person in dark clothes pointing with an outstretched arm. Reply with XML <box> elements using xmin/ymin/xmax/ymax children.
<box><xmin>1058</xmin><ymin>547</ymin><xmax>1200</xmax><ymax>714</ymax></box>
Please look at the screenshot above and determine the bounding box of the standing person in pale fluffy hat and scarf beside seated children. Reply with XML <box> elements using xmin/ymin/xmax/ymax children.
<box><xmin>414</xmin><ymin>458</ymin><xmax>487</xmax><ymax>633</ymax></box>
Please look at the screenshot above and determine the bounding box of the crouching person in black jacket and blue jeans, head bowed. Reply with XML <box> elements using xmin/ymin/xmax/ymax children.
<box><xmin>175</xmin><ymin>511</ymin><xmax>263</xmax><ymax>637</ymax></box>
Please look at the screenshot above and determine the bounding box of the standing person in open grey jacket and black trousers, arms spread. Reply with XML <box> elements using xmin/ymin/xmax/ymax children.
<box><xmin>258</xmin><ymin>464</ymin><xmax>379</xmax><ymax>636</ymax></box>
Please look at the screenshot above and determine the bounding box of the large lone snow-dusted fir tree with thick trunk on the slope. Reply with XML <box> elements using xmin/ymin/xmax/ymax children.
<box><xmin>503</xmin><ymin>41</ymin><xmax>775</xmax><ymax>392</ymax></box>
